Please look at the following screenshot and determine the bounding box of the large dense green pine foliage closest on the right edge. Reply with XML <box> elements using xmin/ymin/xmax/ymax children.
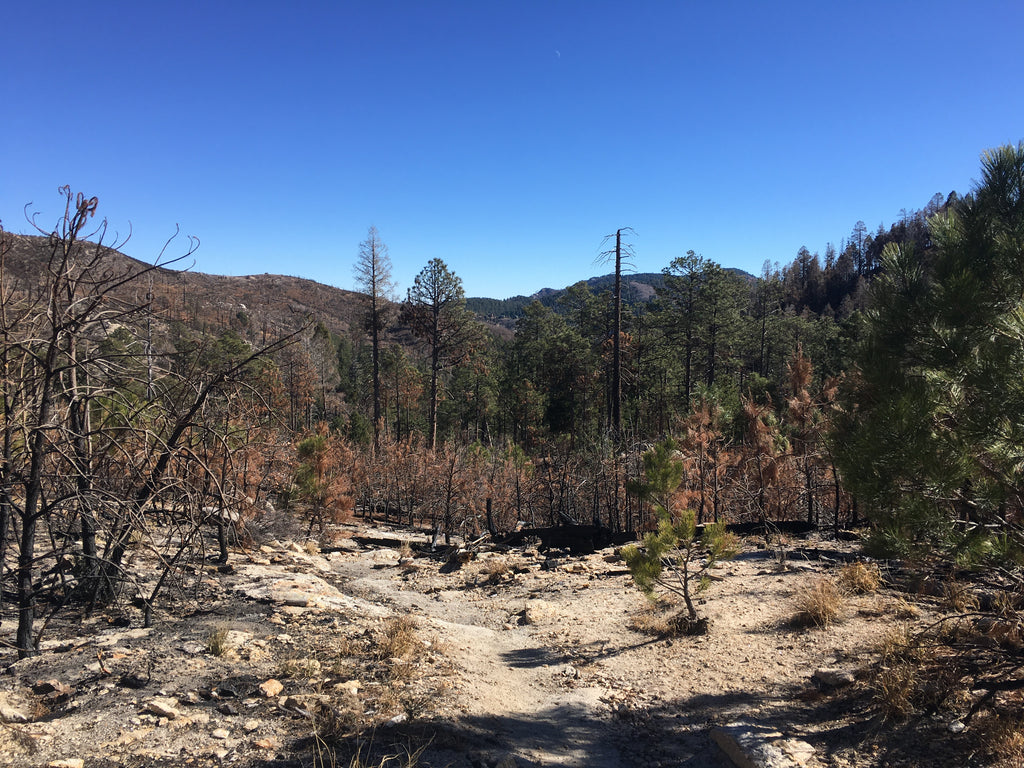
<box><xmin>837</xmin><ymin>144</ymin><xmax>1024</xmax><ymax>561</ymax></box>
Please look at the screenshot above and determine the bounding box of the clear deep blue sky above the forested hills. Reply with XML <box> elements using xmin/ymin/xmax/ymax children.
<box><xmin>0</xmin><ymin>0</ymin><xmax>1024</xmax><ymax>298</ymax></box>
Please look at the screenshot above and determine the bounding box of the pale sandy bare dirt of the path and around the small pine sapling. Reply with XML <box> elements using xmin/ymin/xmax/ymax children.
<box><xmin>321</xmin><ymin>532</ymin><xmax>937</xmax><ymax>768</ymax></box>
